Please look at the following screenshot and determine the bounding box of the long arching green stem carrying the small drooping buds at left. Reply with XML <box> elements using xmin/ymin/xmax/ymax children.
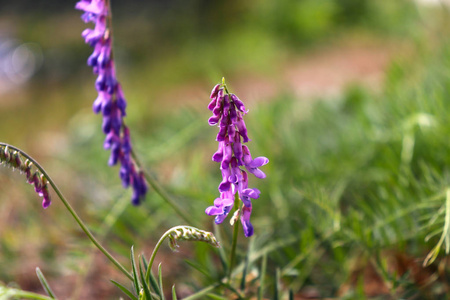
<box><xmin>0</xmin><ymin>143</ymin><xmax>133</xmax><ymax>280</ymax></box>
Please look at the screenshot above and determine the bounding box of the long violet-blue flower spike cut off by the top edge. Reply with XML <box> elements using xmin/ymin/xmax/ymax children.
<box><xmin>75</xmin><ymin>0</ymin><xmax>147</xmax><ymax>205</ymax></box>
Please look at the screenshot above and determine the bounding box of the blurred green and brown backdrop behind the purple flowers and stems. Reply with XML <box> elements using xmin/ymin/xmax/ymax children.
<box><xmin>0</xmin><ymin>0</ymin><xmax>450</xmax><ymax>299</ymax></box>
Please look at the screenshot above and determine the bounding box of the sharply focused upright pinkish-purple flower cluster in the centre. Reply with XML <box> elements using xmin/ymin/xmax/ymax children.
<box><xmin>205</xmin><ymin>83</ymin><xmax>269</xmax><ymax>237</ymax></box>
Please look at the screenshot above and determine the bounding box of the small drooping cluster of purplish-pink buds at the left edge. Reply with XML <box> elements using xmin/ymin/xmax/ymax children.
<box><xmin>0</xmin><ymin>146</ymin><xmax>52</xmax><ymax>208</ymax></box>
